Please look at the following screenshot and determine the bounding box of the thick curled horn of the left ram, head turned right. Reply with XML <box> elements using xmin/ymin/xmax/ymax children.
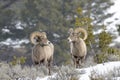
<box><xmin>30</xmin><ymin>31</ymin><xmax>47</xmax><ymax>44</ymax></box>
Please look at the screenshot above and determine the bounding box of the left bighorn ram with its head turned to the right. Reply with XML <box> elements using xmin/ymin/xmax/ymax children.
<box><xmin>30</xmin><ymin>31</ymin><xmax>54</xmax><ymax>74</ymax></box>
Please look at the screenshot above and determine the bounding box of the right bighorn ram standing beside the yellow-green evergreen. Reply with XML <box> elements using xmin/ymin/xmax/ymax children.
<box><xmin>68</xmin><ymin>27</ymin><xmax>87</xmax><ymax>68</ymax></box>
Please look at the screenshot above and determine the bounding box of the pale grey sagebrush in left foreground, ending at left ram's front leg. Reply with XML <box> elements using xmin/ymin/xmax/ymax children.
<box><xmin>0</xmin><ymin>62</ymin><xmax>47</xmax><ymax>80</ymax></box>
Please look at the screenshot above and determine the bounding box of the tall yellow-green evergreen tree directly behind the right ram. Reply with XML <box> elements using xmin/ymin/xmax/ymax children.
<box><xmin>75</xmin><ymin>7</ymin><xmax>95</xmax><ymax>53</ymax></box>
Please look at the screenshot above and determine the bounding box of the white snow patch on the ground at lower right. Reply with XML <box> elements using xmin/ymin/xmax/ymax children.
<box><xmin>78</xmin><ymin>61</ymin><xmax>120</xmax><ymax>80</ymax></box>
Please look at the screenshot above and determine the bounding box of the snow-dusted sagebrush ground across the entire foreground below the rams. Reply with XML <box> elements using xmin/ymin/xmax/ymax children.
<box><xmin>0</xmin><ymin>61</ymin><xmax>120</xmax><ymax>80</ymax></box>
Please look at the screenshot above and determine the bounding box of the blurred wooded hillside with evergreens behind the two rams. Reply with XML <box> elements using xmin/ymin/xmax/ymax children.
<box><xmin>0</xmin><ymin>0</ymin><xmax>120</xmax><ymax>65</ymax></box>
